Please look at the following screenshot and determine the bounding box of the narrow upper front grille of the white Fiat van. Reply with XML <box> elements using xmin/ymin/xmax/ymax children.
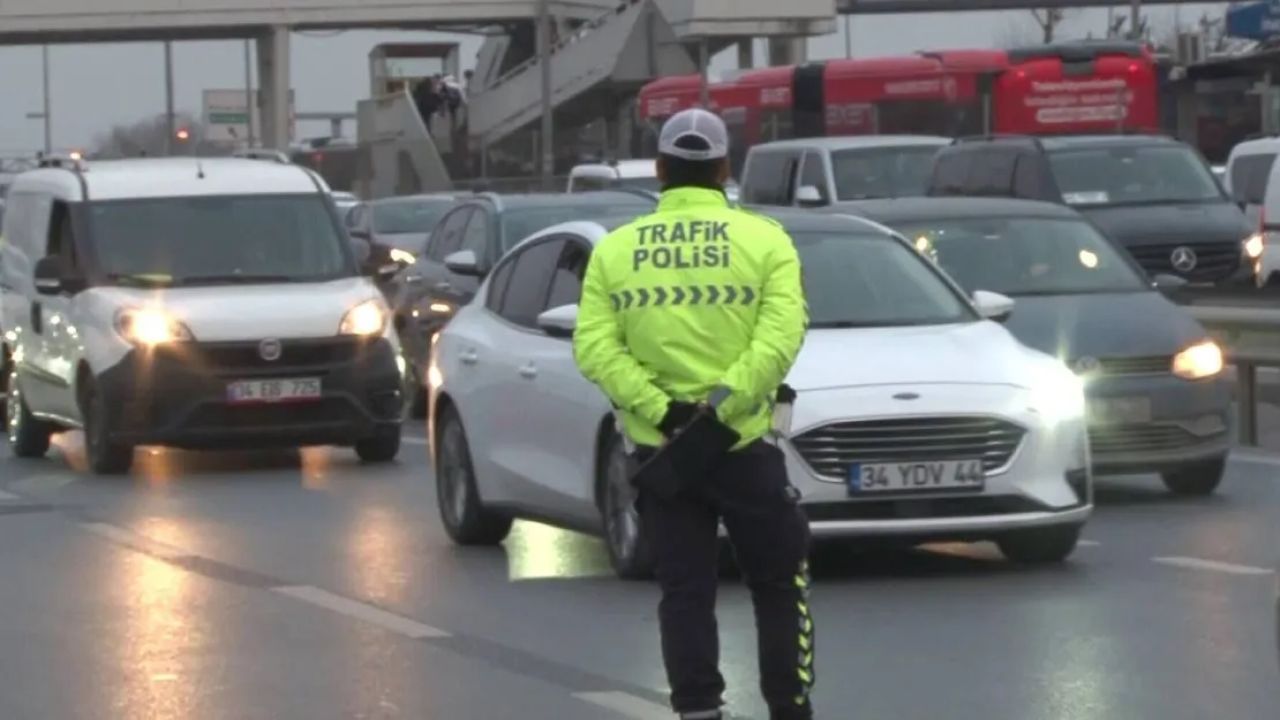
<box><xmin>157</xmin><ymin>337</ymin><xmax>360</xmax><ymax>372</ymax></box>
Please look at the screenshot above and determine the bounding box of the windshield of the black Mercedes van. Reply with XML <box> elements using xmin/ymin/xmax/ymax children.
<box><xmin>1048</xmin><ymin>145</ymin><xmax>1222</xmax><ymax>206</ymax></box>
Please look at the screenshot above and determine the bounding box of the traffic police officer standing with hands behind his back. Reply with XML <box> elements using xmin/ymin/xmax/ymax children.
<box><xmin>573</xmin><ymin>110</ymin><xmax>814</xmax><ymax>720</ymax></box>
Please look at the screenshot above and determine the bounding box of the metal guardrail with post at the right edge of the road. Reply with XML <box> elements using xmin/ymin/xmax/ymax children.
<box><xmin>1187</xmin><ymin>305</ymin><xmax>1280</xmax><ymax>446</ymax></box>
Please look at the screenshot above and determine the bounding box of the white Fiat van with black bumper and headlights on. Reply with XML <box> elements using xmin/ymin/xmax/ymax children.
<box><xmin>0</xmin><ymin>158</ymin><xmax>403</xmax><ymax>473</ymax></box>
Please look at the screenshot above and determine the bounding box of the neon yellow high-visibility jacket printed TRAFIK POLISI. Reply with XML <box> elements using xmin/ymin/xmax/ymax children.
<box><xmin>573</xmin><ymin>188</ymin><xmax>809</xmax><ymax>447</ymax></box>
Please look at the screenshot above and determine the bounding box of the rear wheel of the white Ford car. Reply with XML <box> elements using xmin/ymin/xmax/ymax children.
<box><xmin>435</xmin><ymin>407</ymin><xmax>512</xmax><ymax>544</ymax></box>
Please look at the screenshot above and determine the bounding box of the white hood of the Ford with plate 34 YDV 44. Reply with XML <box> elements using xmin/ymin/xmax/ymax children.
<box><xmin>786</xmin><ymin>322</ymin><xmax>1047</xmax><ymax>392</ymax></box>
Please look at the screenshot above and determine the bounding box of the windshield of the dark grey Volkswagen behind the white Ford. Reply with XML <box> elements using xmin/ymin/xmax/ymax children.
<box><xmin>892</xmin><ymin>212</ymin><xmax>1148</xmax><ymax>295</ymax></box>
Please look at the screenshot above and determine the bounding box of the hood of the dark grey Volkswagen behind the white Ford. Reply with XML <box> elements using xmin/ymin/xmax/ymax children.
<box><xmin>1005</xmin><ymin>291</ymin><xmax>1206</xmax><ymax>361</ymax></box>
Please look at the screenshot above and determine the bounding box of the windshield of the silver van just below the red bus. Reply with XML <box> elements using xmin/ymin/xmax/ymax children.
<box><xmin>831</xmin><ymin>145</ymin><xmax>938</xmax><ymax>200</ymax></box>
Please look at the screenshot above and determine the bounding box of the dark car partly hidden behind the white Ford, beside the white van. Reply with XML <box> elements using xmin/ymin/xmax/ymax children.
<box><xmin>387</xmin><ymin>190</ymin><xmax>658</xmax><ymax>416</ymax></box>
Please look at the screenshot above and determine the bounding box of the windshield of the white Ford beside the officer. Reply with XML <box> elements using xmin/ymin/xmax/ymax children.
<box><xmin>792</xmin><ymin>232</ymin><xmax>977</xmax><ymax>328</ymax></box>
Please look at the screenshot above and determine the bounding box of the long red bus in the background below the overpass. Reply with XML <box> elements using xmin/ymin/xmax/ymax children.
<box><xmin>639</xmin><ymin>41</ymin><xmax>1160</xmax><ymax>172</ymax></box>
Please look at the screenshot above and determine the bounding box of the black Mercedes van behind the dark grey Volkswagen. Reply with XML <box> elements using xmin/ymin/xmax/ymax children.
<box><xmin>929</xmin><ymin>135</ymin><xmax>1262</xmax><ymax>286</ymax></box>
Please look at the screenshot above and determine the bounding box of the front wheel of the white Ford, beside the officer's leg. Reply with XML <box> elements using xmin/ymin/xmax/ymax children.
<box><xmin>600</xmin><ymin>434</ymin><xmax>654</xmax><ymax>580</ymax></box>
